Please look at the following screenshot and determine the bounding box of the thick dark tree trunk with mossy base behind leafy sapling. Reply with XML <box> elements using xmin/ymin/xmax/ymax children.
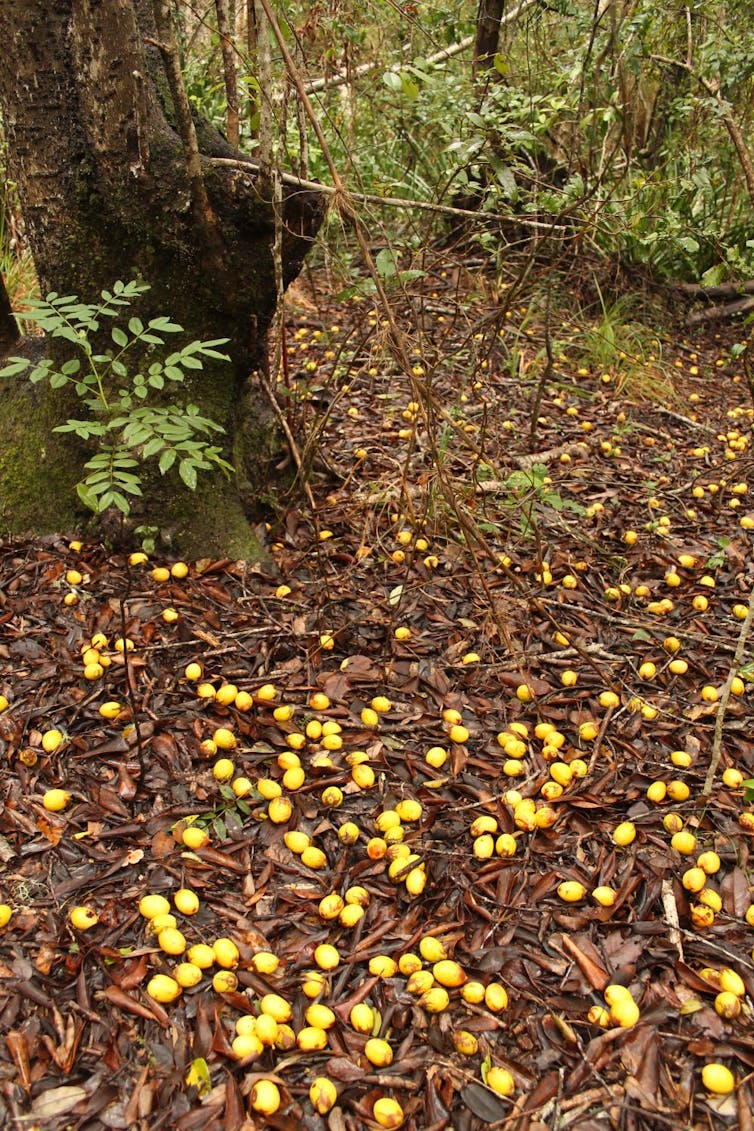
<box><xmin>0</xmin><ymin>0</ymin><xmax>323</xmax><ymax>556</ymax></box>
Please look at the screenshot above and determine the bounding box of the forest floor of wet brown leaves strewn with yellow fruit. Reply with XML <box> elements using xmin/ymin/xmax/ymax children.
<box><xmin>0</xmin><ymin>256</ymin><xmax>754</xmax><ymax>1131</ymax></box>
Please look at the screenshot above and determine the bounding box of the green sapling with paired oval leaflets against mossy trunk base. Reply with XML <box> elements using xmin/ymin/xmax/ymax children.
<box><xmin>0</xmin><ymin>280</ymin><xmax>233</xmax><ymax>516</ymax></box>
